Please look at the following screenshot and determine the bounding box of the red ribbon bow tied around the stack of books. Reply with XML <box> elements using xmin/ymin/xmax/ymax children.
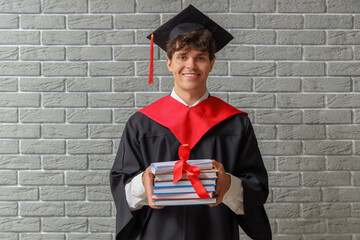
<box><xmin>173</xmin><ymin>144</ymin><xmax>210</xmax><ymax>198</ymax></box>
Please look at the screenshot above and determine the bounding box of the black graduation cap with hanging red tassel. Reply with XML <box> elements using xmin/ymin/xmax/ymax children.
<box><xmin>147</xmin><ymin>5</ymin><xmax>234</xmax><ymax>84</ymax></box>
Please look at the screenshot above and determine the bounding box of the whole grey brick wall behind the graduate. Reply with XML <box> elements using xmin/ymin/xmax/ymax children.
<box><xmin>0</xmin><ymin>0</ymin><xmax>360</xmax><ymax>240</ymax></box>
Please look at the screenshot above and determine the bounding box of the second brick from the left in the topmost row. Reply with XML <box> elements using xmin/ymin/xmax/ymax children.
<box><xmin>42</xmin><ymin>0</ymin><xmax>87</xmax><ymax>13</ymax></box>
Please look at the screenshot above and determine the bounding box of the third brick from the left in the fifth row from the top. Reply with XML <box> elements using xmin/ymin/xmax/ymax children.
<box><xmin>90</xmin><ymin>62</ymin><xmax>134</xmax><ymax>76</ymax></box>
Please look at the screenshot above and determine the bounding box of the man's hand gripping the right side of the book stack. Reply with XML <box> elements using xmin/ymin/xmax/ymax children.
<box><xmin>210</xmin><ymin>160</ymin><xmax>231</xmax><ymax>207</ymax></box>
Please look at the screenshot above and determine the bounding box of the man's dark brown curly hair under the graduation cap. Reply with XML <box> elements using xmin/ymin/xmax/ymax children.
<box><xmin>166</xmin><ymin>29</ymin><xmax>216</xmax><ymax>61</ymax></box>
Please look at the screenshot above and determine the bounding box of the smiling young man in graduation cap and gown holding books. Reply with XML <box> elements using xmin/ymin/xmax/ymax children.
<box><xmin>110</xmin><ymin>5</ymin><xmax>271</xmax><ymax>240</ymax></box>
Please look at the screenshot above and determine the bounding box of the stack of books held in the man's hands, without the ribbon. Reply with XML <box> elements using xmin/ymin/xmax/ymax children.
<box><xmin>151</xmin><ymin>159</ymin><xmax>217</xmax><ymax>206</ymax></box>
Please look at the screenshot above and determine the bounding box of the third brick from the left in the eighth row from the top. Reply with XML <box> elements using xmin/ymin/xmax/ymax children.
<box><xmin>67</xmin><ymin>109</ymin><xmax>112</xmax><ymax>123</ymax></box>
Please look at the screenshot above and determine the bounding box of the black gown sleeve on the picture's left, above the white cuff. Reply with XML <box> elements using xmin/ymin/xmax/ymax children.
<box><xmin>110</xmin><ymin>121</ymin><xmax>150</xmax><ymax>240</ymax></box>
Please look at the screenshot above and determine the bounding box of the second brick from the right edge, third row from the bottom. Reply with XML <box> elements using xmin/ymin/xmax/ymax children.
<box><xmin>301</xmin><ymin>203</ymin><xmax>350</xmax><ymax>218</ymax></box>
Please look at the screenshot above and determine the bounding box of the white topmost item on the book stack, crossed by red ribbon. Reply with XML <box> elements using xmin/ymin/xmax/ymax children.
<box><xmin>151</xmin><ymin>159</ymin><xmax>213</xmax><ymax>174</ymax></box>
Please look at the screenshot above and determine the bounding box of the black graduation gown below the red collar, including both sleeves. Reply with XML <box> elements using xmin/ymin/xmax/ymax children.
<box><xmin>110</xmin><ymin>109</ymin><xmax>271</xmax><ymax>240</ymax></box>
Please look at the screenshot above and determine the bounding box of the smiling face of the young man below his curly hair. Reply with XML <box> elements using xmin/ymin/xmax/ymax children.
<box><xmin>166</xmin><ymin>48</ymin><xmax>215</xmax><ymax>95</ymax></box>
